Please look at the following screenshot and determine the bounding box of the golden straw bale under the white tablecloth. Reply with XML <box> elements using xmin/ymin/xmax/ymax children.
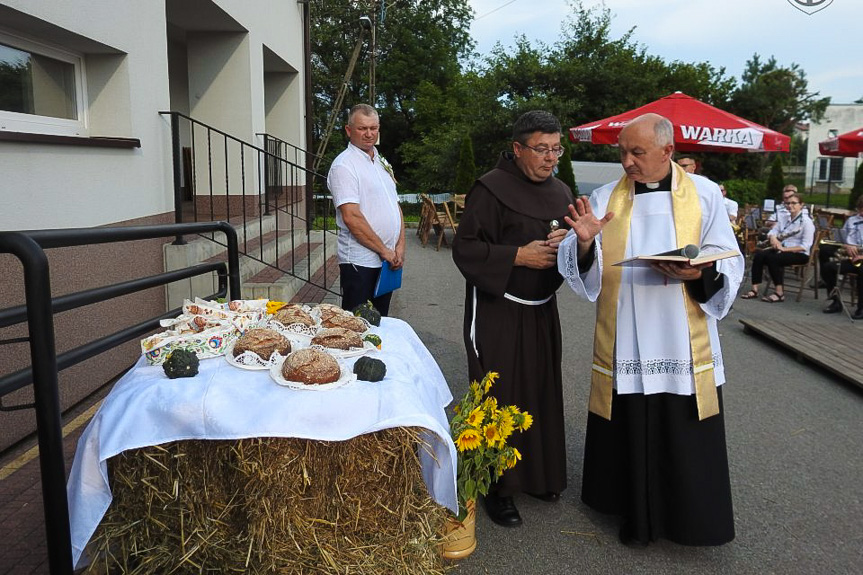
<box><xmin>87</xmin><ymin>428</ymin><xmax>447</xmax><ymax>575</ymax></box>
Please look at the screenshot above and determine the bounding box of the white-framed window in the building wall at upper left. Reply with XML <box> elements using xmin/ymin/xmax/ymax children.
<box><xmin>0</xmin><ymin>32</ymin><xmax>86</xmax><ymax>135</ymax></box>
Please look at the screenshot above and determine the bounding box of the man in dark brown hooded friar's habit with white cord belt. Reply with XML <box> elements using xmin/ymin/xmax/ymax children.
<box><xmin>453</xmin><ymin>111</ymin><xmax>572</xmax><ymax>527</ymax></box>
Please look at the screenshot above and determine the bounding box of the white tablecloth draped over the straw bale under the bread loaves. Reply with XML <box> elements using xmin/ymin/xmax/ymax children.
<box><xmin>67</xmin><ymin>318</ymin><xmax>458</xmax><ymax>566</ymax></box>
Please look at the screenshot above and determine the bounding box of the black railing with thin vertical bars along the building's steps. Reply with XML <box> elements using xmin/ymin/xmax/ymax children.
<box><xmin>160</xmin><ymin>112</ymin><xmax>338</xmax><ymax>295</ymax></box>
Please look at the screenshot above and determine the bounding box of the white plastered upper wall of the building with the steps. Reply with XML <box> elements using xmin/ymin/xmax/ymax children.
<box><xmin>0</xmin><ymin>0</ymin><xmax>304</xmax><ymax>230</ymax></box>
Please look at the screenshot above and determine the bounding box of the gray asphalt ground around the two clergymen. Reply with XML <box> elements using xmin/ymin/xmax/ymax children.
<box><xmin>391</xmin><ymin>234</ymin><xmax>863</xmax><ymax>575</ymax></box>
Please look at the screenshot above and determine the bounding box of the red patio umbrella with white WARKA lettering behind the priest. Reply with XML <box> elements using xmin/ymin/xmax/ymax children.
<box><xmin>569</xmin><ymin>92</ymin><xmax>791</xmax><ymax>152</ymax></box>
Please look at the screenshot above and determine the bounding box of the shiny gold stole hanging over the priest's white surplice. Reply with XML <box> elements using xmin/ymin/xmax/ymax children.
<box><xmin>589</xmin><ymin>164</ymin><xmax>719</xmax><ymax>420</ymax></box>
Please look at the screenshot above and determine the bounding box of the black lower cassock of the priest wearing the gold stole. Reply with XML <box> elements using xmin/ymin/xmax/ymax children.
<box><xmin>581</xmin><ymin>387</ymin><xmax>734</xmax><ymax>545</ymax></box>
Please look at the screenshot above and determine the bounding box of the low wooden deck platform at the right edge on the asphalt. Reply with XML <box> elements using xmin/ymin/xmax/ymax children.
<box><xmin>740</xmin><ymin>319</ymin><xmax>863</xmax><ymax>387</ymax></box>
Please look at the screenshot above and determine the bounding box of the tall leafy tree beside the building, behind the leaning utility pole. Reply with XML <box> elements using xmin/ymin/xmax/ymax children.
<box><xmin>311</xmin><ymin>0</ymin><xmax>473</xmax><ymax>185</ymax></box>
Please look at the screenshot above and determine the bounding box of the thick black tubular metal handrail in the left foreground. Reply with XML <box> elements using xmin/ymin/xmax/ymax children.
<box><xmin>0</xmin><ymin>222</ymin><xmax>240</xmax><ymax>575</ymax></box>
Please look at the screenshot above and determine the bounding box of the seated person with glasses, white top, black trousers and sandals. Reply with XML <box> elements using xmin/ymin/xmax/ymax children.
<box><xmin>741</xmin><ymin>194</ymin><xmax>815</xmax><ymax>303</ymax></box>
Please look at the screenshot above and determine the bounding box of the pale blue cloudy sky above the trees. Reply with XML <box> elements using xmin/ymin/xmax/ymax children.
<box><xmin>469</xmin><ymin>0</ymin><xmax>863</xmax><ymax>104</ymax></box>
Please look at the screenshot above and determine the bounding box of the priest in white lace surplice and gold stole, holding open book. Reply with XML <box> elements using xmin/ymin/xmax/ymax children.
<box><xmin>558</xmin><ymin>114</ymin><xmax>743</xmax><ymax>545</ymax></box>
